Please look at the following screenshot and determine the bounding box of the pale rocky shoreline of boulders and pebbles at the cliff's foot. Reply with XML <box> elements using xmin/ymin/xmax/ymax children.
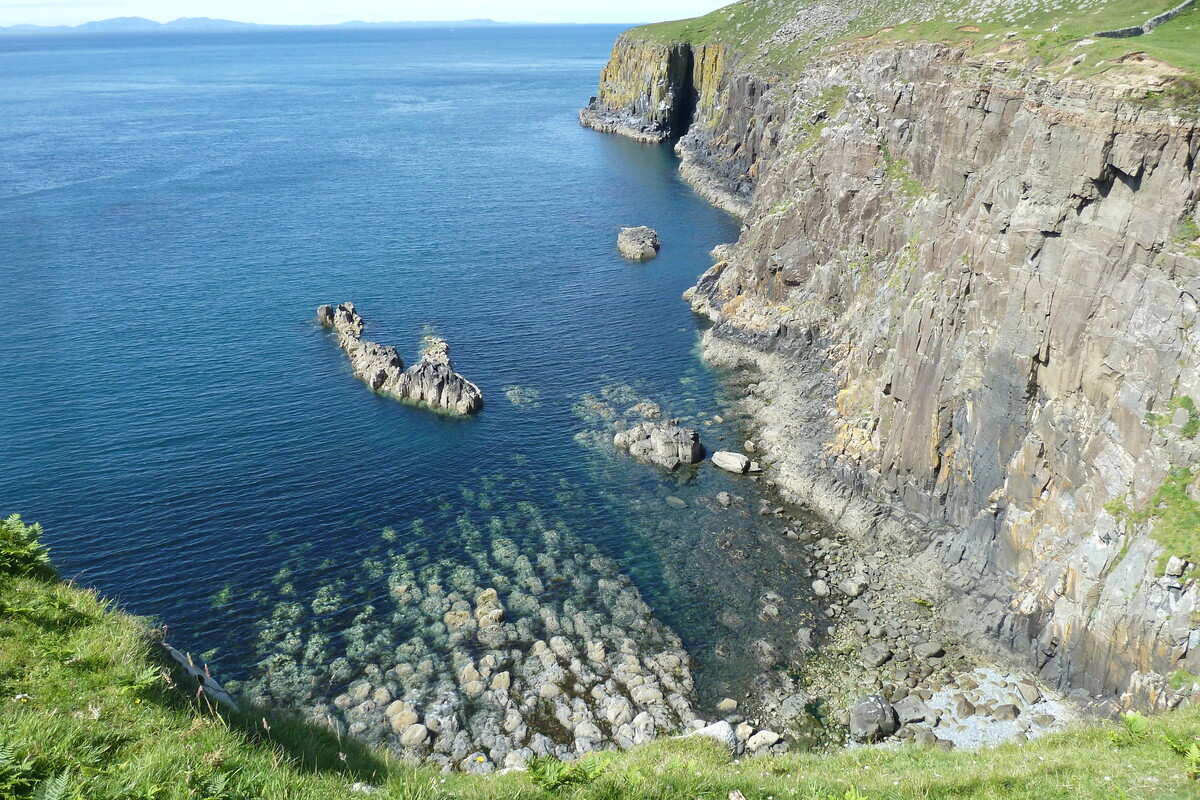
<box><xmin>686</xmin><ymin>327</ymin><xmax>1089</xmax><ymax>748</ymax></box>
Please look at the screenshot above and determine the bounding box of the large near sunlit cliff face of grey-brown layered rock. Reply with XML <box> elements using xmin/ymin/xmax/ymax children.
<box><xmin>588</xmin><ymin>32</ymin><xmax>1200</xmax><ymax>706</ymax></box>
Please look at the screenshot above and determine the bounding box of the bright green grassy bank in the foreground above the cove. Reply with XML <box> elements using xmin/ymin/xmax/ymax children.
<box><xmin>0</xmin><ymin>517</ymin><xmax>1200</xmax><ymax>800</ymax></box>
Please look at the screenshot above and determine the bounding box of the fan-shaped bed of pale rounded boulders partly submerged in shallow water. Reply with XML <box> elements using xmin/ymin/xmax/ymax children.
<box><xmin>247</xmin><ymin>503</ymin><xmax>697</xmax><ymax>771</ymax></box>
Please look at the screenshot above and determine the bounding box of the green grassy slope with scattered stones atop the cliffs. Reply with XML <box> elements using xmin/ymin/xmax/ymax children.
<box><xmin>629</xmin><ymin>0</ymin><xmax>1200</xmax><ymax>87</ymax></box>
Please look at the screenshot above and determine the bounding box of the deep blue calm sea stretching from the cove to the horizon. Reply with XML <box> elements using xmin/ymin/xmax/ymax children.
<box><xmin>0</xmin><ymin>26</ymin><xmax>816</xmax><ymax>710</ymax></box>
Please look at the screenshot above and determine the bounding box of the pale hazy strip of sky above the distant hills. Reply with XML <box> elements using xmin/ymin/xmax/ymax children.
<box><xmin>0</xmin><ymin>0</ymin><xmax>731</xmax><ymax>25</ymax></box>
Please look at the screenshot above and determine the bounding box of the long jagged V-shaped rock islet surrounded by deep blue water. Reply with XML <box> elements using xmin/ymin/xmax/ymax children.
<box><xmin>317</xmin><ymin>302</ymin><xmax>484</xmax><ymax>414</ymax></box>
